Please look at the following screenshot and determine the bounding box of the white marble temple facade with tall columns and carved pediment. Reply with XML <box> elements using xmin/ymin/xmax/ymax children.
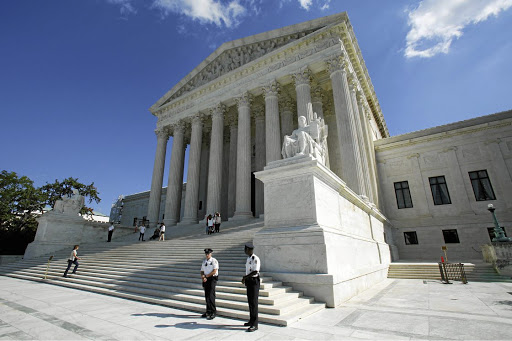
<box><xmin>142</xmin><ymin>13</ymin><xmax>389</xmax><ymax>226</ymax></box>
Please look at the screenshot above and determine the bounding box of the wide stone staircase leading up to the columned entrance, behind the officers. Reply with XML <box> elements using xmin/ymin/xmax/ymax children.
<box><xmin>0</xmin><ymin>220</ymin><xmax>325</xmax><ymax>326</ymax></box>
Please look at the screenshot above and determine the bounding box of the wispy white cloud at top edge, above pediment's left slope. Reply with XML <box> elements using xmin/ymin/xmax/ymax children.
<box><xmin>153</xmin><ymin>0</ymin><xmax>246</xmax><ymax>27</ymax></box>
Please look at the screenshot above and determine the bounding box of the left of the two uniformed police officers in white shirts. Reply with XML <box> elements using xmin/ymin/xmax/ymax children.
<box><xmin>201</xmin><ymin>249</ymin><xmax>219</xmax><ymax>320</ymax></box>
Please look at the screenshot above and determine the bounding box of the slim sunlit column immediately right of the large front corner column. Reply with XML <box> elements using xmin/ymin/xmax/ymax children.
<box><xmin>349</xmin><ymin>74</ymin><xmax>373</xmax><ymax>202</ymax></box>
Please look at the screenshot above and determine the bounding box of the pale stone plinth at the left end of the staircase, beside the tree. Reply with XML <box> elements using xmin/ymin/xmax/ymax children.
<box><xmin>23</xmin><ymin>210</ymin><xmax>133</xmax><ymax>259</ymax></box>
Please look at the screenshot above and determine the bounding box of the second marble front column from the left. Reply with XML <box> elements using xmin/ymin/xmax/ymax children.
<box><xmin>164</xmin><ymin>123</ymin><xmax>185</xmax><ymax>226</ymax></box>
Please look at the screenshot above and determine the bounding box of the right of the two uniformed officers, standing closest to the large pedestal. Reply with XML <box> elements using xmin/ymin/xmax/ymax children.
<box><xmin>242</xmin><ymin>243</ymin><xmax>261</xmax><ymax>332</ymax></box>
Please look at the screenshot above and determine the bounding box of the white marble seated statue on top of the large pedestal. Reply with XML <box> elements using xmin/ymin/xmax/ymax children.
<box><xmin>281</xmin><ymin>103</ymin><xmax>328</xmax><ymax>166</ymax></box>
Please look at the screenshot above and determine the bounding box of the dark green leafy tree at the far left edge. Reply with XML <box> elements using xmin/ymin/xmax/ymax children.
<box><xmin>0</xmin><ymin>170</ymin><xmax>101</xmax><ymax>254</ymax></box>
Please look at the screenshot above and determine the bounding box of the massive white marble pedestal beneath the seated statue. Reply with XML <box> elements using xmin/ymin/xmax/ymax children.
<box><xmin>254</xmin><ymin>155</ymin><xmax>391</xmax><ymax>307</ymax></box>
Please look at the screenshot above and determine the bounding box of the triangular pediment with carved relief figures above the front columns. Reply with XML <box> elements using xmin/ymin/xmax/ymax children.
<box><xmin>150</xmin><ymin>12</ymin><xmax>347</xmax><ymax>112</ymax></box>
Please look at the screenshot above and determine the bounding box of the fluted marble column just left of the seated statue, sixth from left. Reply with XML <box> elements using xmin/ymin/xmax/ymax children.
<box><xmin>264</xmin><ymin>80</ymin><xmax>281</xmax><ymax>165</ymax></box>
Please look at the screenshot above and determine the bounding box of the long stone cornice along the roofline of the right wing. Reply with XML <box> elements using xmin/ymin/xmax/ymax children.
<box><xmin>374</xmin><ymin>110</ymin><xmax>512</xmax><ymax>152</ymax></box>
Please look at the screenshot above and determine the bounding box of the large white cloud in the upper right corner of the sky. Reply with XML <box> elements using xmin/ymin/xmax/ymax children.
<box><xmin>404</xmin><ymin>0</ymin><xmax>512</xmax><ymax>58</ymax></box>
